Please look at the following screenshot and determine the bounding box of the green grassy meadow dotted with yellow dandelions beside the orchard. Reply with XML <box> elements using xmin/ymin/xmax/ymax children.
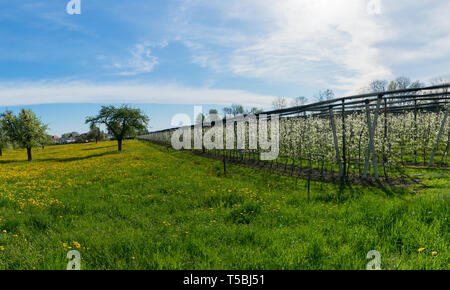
<box><xmin>0</xmin><ymin>140</ymin><xmax>450</xmax><ymax>270</ymax></box>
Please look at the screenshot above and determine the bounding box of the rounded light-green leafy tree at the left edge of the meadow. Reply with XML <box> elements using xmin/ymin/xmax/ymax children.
<box><xmin>2</xmin><ymin>109</ymin><xmax>47</xmax><ymax>161</ymax></box>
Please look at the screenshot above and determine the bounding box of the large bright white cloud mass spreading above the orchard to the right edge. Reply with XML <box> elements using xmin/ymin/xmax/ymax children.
<box><xmin>174</xmin><ymin>0</ymin><xmax>450</xmax><ymax>93</ymax></box>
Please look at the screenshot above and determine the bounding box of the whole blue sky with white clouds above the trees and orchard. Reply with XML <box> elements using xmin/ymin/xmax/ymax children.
<box><xmin>0</xmin><ymin>0</ymin><xmax>450</xmax><ymax>135</ymax></box>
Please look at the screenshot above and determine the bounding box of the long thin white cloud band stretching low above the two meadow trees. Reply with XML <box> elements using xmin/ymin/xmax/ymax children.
<box><xmin>0</xmin><ymin>82</ymin><xmax>274</xmax><ymax>108</ymax></box>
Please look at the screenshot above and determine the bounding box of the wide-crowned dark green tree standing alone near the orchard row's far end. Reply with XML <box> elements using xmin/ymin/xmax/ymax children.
<box><xmin>86</xmin><ymin>105</ymin><xmax>149</xmax><ymax>151</ymax></box>
